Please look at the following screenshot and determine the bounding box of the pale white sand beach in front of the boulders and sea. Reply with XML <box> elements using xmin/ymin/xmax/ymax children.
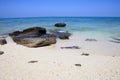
<box><xmin>0</xmin><ymin>36</ymin><xmax>120</xmax><ymax>80</ymax></box>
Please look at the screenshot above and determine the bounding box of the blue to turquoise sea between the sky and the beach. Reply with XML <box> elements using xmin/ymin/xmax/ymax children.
<box><xmin>0</xmin><ymin>17</ymin><xmax>120</xmax><ymax>36</ymax></box>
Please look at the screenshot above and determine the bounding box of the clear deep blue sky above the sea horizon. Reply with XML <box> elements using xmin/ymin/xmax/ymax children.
<box><xmin>0</xmin><ymin>0</ymin><xmax>120</xmax><ymax>18</ymax></box>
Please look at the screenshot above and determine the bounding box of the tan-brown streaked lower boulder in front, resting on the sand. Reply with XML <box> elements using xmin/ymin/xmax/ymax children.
<box><xmin>13</xmin><ymin>34</ymin><xmax>56</xmax><ymax>48</ymax></box>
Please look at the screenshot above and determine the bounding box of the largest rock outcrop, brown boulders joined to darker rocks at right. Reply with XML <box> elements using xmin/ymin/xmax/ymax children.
<box><xmin>9</xmin><ymin>27</ymin><xmax>71</xmax><ymax>48</ymax></box>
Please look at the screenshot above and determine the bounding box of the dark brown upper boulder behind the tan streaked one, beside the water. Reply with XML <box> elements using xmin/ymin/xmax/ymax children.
<box><xmin>9</xmin><ymin>27</ymin><xmax>47</xmax><ymax>37</ymax></box>
